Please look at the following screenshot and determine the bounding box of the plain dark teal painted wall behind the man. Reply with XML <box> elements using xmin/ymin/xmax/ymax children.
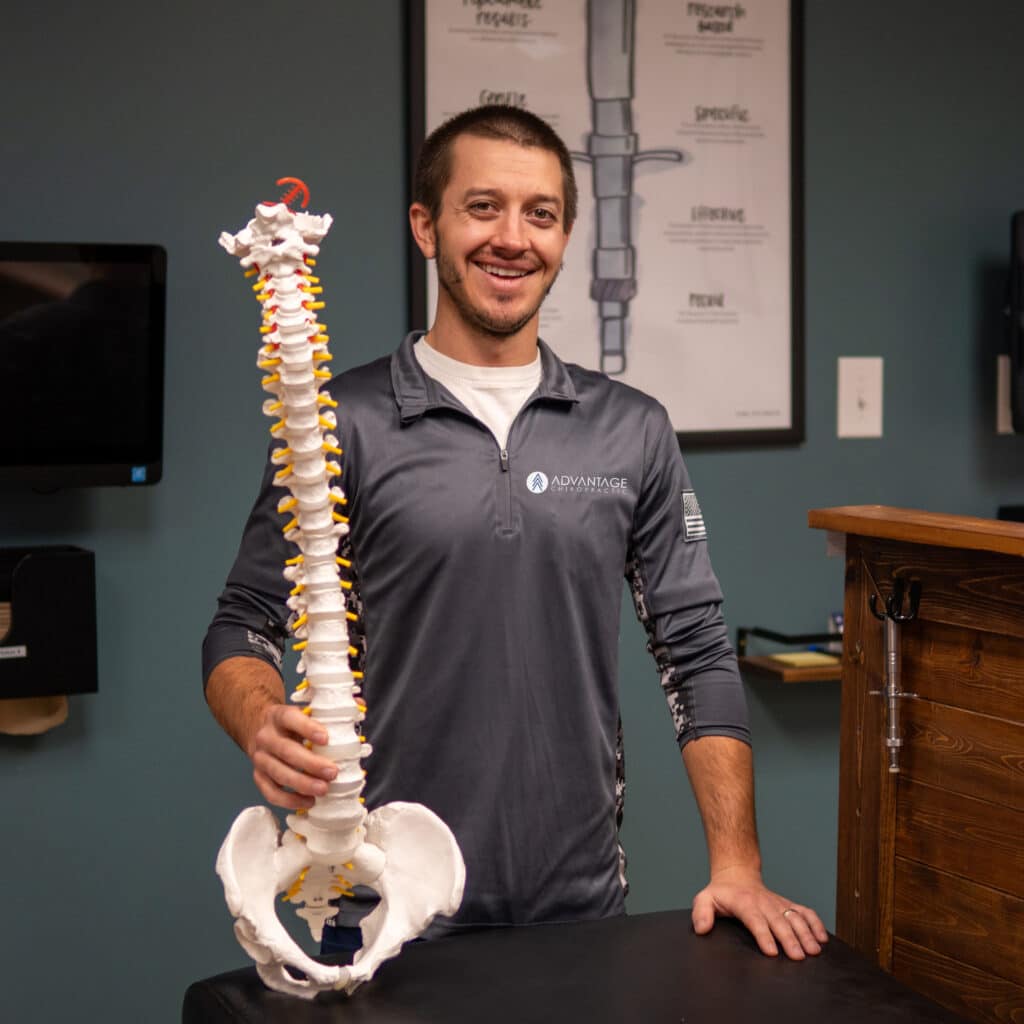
<box><xmin>0</xmin><ymin>0</ymin><xmax>1024</xmax><ymax>1022</ymax></box>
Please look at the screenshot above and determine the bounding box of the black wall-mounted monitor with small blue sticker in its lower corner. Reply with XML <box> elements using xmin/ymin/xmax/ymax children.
<box><xmin>0</xmin><ymin>242</ymin><xmax>167</xmax><ymax>488</ymax></box>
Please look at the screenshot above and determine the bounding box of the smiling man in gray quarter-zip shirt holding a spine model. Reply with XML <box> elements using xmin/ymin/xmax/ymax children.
<box><xmin>204</xmin><ymin>106</ymin><xmax>826</xmax><ymax>958</ymax></box>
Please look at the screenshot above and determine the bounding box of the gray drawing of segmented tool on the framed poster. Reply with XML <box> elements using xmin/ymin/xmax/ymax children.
<box><xmin>572</xmin><ymin>0</ymin><xmax>691</xmax><ymax>375</ymax></box>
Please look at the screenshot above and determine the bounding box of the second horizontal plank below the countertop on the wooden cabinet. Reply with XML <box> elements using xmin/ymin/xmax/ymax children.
<box><xmin>902</xmin><ymin>621</ymin><xmax>1024</xmax><ymax>722</ymax></box>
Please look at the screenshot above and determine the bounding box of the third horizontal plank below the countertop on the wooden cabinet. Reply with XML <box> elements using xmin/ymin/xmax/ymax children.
<box><xmin>900</xmin><ymin>700</ymin><xmax>1024</xmax><ymax>811</ymax></box>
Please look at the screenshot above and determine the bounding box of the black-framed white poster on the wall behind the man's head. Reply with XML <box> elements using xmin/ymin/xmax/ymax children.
<box><xmin>409</xmin><ymin>0</ymin><xmax>804</xmax><ymax>449</ymax></box>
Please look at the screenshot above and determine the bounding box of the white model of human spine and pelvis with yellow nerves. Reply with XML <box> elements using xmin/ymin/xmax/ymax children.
<box><xmin>217</xmin><ymin>178</ymin><xmax>466</xmax><ymax>998</ymax></box>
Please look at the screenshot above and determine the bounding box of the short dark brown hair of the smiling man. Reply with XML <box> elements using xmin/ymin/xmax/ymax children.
<box><xmin>413</xmin><ymin>103</ymin><xmax>578</xmax><ymax>231</ymax></box>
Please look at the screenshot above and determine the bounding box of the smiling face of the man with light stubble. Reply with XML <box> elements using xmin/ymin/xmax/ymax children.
<box><xmin>425</xmin><ymin>135</ymin><xmax>568</xmax><ymax>338</ymax></box>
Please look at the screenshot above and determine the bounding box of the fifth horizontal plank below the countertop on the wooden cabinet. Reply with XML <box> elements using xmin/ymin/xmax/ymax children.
<box><xmin>894</xmin><ymin>857</ymin><xmax>1024</xmax><ymax>985</ymax></box>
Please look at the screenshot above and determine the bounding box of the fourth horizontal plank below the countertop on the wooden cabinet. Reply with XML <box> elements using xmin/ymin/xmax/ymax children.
<box><xmin>896</xmin><ymin>776</ymin><xmax>1024</xmax><ymax>901</ymax></box>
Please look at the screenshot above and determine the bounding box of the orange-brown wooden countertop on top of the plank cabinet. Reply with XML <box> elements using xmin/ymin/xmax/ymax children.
<box><xmin>807</xmin><ymin>505</ymin><xmax>1024</xmax><ymax>556</ymax></box>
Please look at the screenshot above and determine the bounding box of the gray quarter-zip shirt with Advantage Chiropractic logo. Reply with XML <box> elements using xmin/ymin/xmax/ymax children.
<box><xmin>203</xmin><ymin>335</ymin><xmax>749</xmax><ymax>934</ymax></box>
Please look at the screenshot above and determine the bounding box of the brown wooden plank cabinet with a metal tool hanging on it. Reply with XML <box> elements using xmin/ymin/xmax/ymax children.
<box><xmin>809</xmin><ymin>506</ymin><xmax>1024</xmax><ymax>1024</ymax></box>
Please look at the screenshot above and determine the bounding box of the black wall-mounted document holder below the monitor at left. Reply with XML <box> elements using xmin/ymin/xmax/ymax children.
<box><xmin>0</xmin><ymin>545</ymin><xmax>98</xmax><ymax>699</ymax></box>
